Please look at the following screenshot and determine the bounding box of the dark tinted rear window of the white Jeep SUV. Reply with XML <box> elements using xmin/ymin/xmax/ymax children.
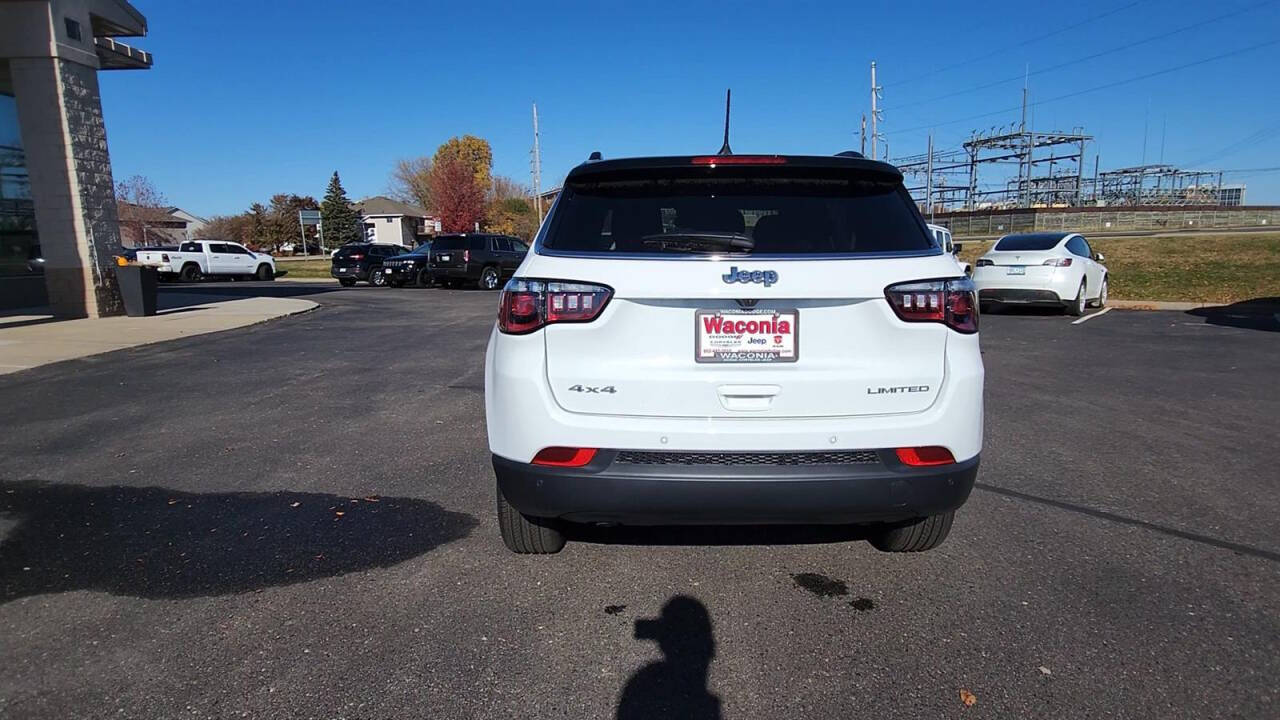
<box><xmin>543</xmin><ymin>177</ymin><xmax>936</xmax><ymax>255</ymax></box>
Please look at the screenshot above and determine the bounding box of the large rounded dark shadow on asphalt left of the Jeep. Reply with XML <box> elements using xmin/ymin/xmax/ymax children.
<box><xmin>0</xmin><ymin>480</ymin><xmax>476</xmax><ymax>602</ymax></box>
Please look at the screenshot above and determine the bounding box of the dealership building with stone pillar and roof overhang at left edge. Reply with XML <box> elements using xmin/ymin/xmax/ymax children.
<box><xmin>0</xmin><ymin>0</ymin><xmax>151</xmax><ymax>318</ymax></box>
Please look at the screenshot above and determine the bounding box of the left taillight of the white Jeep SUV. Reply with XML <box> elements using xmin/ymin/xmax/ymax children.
<box><xmin>498</xmin><ymin>278</ymin><xmax>613</xmax><ymax>334</ymax></box>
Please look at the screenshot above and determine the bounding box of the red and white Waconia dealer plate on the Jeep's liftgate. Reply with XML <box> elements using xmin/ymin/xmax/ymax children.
<box><xmin>694</xmin><ymin>310</ymin><xmax>800</xmax><ymax>363</ymax></box>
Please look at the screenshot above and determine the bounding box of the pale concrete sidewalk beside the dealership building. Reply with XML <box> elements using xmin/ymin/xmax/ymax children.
<box><xmin>0</xmin><ymin>297</ymin><xmax>316</xmax><ymax>374</ymax></box>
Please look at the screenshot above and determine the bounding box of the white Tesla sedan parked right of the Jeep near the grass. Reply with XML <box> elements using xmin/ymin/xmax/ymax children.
<box><xmin>973</xmin><ymin>232</ymin><xmax>1107</xmax><ymax>315</ymax></box>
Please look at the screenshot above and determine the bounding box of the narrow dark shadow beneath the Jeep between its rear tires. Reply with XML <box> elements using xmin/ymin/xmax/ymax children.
<box><xmin>564</xmin><ymin>523</ymin><xmax>873</xmax><ymax>546</ymax></box>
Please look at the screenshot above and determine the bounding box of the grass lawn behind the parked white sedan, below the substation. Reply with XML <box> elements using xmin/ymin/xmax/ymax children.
<box><xmin>957</xmin><ymin>232</ymin><xmax>1280</xmax><ymax>304</ymax></box>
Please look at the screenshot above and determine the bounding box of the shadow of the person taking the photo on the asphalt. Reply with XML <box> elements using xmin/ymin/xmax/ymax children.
<box><xmin>617</xmin><ymin>596</ymin><xmax>721</xmax><ymax>720</ymax></box>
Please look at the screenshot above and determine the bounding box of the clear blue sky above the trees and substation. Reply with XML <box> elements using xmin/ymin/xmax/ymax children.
<box><xmin>101</xmin><ymin>0</ymin><xmax>1280</xmax><ymax>215</ymax></box>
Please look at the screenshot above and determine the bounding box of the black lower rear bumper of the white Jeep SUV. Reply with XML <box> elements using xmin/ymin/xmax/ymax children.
<box><xmin>493</xmin><ymin>451</ymin><xmax>979</xmax><ymax>525</ymax></box>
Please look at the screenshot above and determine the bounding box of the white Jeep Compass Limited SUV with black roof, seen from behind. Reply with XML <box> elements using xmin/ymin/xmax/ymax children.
<box><xmin>485</xmin><ymin>152</ymin><xmax>983</xmax><ymax>552</ymax></box>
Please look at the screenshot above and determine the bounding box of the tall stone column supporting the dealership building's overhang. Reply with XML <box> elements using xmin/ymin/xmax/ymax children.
<box><xmin>9</xmin><ymin>58</ymin><xmax>123</xmax><ymax>318</ymax></box>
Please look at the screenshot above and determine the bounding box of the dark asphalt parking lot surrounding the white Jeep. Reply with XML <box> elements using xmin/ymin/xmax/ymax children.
<box><xmin>0</xmin><ymin>283</ymin><xmax>1280</xmax><ymax>719</ymax></box>
